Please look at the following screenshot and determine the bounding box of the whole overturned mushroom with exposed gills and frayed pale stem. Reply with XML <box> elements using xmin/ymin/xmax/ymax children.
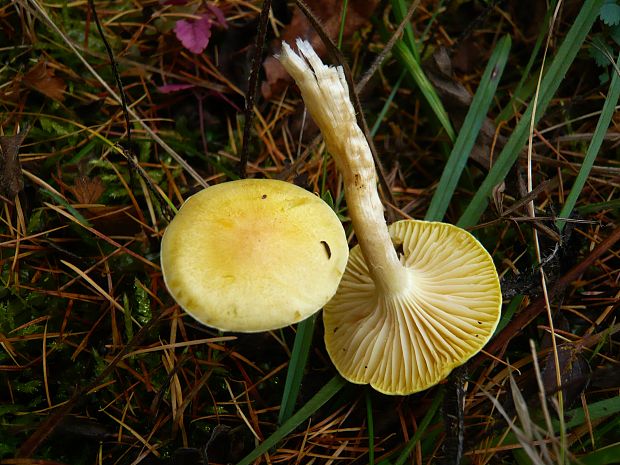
<box><xmin>279</xmin><ymin>40</ymin><xmax>501</xmax><ymax>394</ymax></box>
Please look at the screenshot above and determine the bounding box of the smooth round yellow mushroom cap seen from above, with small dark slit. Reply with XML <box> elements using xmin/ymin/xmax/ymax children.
<box><xmin>161</xmin><ymin>179</ymin><xmax>349</xmax><ymax>332</ymax></box>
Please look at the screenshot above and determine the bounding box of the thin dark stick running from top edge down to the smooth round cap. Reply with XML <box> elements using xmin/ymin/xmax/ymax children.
<box><xmin>239</xmin><ymin>0</ymin><xmax>271</xmax><ymax>178</ymax></box>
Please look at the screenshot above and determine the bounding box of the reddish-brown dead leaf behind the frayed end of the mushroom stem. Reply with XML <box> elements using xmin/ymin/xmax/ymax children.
<box><xmin>261</xmin><ymin>0</ymin><xmax>379</xmax><ymax>99</ymax></box>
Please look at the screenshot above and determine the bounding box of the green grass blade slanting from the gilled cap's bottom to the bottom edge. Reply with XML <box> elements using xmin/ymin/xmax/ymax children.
<box><xmin>237</xmin><ymin>375</ymin><xmax>347</xmax><ymax>465</ymax></box>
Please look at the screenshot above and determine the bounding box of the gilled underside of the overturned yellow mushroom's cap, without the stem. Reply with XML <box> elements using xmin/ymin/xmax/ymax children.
<box><xmin>323</xmin><ymin>220</ymin><xmax>502</xmax><ymax>394</ymax></box>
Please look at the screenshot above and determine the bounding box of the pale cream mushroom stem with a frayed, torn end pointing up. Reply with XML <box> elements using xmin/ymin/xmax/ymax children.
<box><xmin>279</xmin><ymin>39</ymin><xmax>410</xmax><ymax>294</ymax></box>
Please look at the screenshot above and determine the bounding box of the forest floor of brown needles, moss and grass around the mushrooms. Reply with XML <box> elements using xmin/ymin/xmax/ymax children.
<box><xmin>0</xmin><ymin>0</ymin><xmax>620</xmax><ymax>465</ymax></box>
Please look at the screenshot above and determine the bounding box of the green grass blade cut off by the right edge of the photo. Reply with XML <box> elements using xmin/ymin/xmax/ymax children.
<box><xmin>555</xmin><ymin>55</ymin><xmax>620</xmax><ymax>231</ymax></box>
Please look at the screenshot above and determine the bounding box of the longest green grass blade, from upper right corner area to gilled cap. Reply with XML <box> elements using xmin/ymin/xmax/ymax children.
<box><xmin>457</xmin><ymin>0</ymin><xmax>603</xmax><ymax>227</ymax></box>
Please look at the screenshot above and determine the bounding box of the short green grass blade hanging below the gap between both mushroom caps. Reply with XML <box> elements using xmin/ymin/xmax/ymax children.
<box><xmin>278</xmin><ymin>315</ymin><xmax>316</xmax><ymax>425</ymax></box>
